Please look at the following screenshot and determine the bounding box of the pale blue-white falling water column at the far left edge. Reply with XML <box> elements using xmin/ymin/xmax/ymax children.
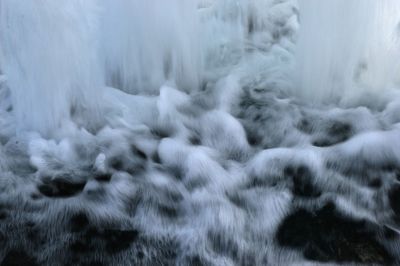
<box><xmin>0</xmin><ymin>0</ymin><xmax>103</xmax><ymax>136</ymax></box>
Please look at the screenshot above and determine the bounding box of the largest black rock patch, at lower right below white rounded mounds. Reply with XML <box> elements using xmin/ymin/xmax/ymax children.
<box><xmin>276</xmin><ymin>203</ymin><xmax>393</xmax><ymax>264</ymax></box>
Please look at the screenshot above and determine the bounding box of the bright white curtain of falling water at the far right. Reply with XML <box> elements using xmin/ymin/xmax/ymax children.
<box><xmin>295</xmin><ymin>0</ymin><xmax>400</xmax><ymax>102</ymax></box>
